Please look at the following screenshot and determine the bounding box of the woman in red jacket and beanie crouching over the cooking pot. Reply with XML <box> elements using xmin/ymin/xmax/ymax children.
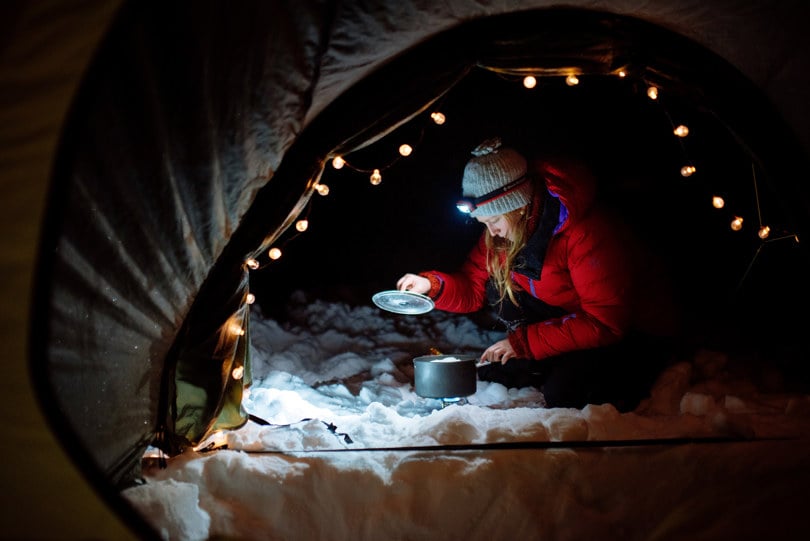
<box><xmin>397</xmin><ymin>139</ymin><xmax>676</xmax><ymax>410</ymax></box>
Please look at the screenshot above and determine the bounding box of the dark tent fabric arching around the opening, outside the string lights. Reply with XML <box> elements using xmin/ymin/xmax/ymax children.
<box><xmin>6</xmin><ymin>0</ymin><xmax>810</xmax><ymax>536</ymax></box>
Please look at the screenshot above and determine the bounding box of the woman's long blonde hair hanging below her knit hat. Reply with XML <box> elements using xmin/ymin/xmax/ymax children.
<box><xmin>485</xmin><ymin>207</ymin><xmax>530</xmax><ymax>306</ymax></box>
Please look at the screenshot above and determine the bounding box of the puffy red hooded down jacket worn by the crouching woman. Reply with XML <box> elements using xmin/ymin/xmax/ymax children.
<box><xmin>422</xmin><ymin>158</ymin><xmax>674</xmax><ymax>359</ymax></box>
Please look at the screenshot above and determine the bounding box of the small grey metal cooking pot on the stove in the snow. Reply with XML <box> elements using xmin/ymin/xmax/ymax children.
<box><xmin>413</xmin><ymin>355</ymin><xmax>477</xmax><ymax>398</ymax></box>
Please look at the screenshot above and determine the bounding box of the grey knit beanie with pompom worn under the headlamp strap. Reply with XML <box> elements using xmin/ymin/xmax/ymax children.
<box><xmin>461</xmin><ymin>138</ymin><xmax>532</xmax><ymax>217</ymax></box>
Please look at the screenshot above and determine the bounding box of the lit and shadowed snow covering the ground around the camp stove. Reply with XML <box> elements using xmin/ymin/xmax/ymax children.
<box><xmin>123</xmin><ymin>292</ymin><xmax>810</xmax><ymax>540</ymax></box>
